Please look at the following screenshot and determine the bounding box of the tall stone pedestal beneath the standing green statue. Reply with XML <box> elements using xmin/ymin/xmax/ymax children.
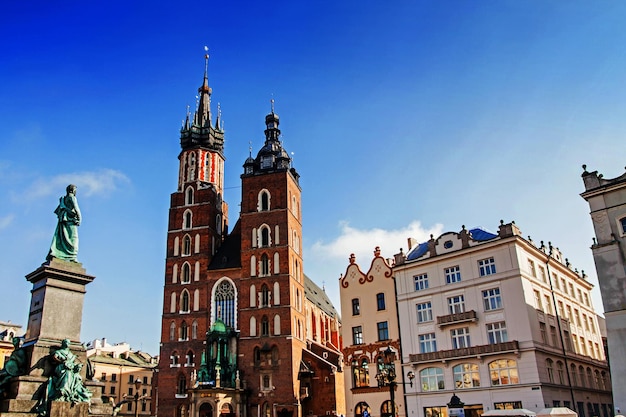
<box><xmin>0</xmin><ymin>258</ymin><xmax>111</xmax><ymax>417</ymax></box>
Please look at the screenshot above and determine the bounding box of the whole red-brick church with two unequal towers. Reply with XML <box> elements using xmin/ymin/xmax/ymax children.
<box><xmin>152</xmin><ymin>57</ymin><xmax>345</xmax><ymax>417</ymax></box>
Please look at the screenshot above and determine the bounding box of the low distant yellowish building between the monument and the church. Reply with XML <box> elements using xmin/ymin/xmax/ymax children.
<box><xmin>87</xmin><ymin>339</ymin><xmax>158</xmax><ymax>416</ymax></box>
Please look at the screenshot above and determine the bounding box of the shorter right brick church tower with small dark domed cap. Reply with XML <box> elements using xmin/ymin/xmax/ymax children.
<box><xmin>240</xmin><ymin>108</ymin><xmax>306</xmax><ymax>417</ymax></box>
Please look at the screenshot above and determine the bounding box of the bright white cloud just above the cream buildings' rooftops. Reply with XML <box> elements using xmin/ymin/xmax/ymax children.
<box><xmin>310</xmin><ymin>220</ymin><xmax>443</xmax><ymax>266</ymax></box>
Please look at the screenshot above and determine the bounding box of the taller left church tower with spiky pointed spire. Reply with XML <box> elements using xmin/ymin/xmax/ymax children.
<box><xmin>153</xmin><ymin>55</ymin><xmax>228</xmax><ymax>416</ymax></box>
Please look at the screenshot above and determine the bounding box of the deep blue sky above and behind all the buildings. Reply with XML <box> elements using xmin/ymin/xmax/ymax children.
<box><xmin>0</xmin><ymin>0</ymin><xmax>626</xmax><ymax>354</ymax></box>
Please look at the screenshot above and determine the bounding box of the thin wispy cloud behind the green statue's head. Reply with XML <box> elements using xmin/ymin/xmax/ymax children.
<box><xmin>24</xmin><ymin>169</ymin><xmax>130</xmax><ymax>199</ymax></box>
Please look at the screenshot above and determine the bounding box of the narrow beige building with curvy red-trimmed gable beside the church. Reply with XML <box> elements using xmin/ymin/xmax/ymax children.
<box><xmin>339</xmin><ymin>247</ymin><xmax>407</xmax><ymax>417</ymax></box>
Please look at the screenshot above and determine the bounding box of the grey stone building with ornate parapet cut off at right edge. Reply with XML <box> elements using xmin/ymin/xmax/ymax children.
<box><xmin>581</xmin><ymin>165</ymin><xmax>626</xmax><ymax>414</ymax></box>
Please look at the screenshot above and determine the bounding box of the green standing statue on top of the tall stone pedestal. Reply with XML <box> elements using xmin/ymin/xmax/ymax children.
<box><xmin>46</xmin><ymin>184</ymin><xmax>81</xmax><ymax>262</ymax></box>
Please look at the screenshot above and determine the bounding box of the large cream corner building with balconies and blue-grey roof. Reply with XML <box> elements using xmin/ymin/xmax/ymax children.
<box><xmin>393</xmin><ymin>222</ymin><xmax>613</xmax><ymax>417</ymax></box>
